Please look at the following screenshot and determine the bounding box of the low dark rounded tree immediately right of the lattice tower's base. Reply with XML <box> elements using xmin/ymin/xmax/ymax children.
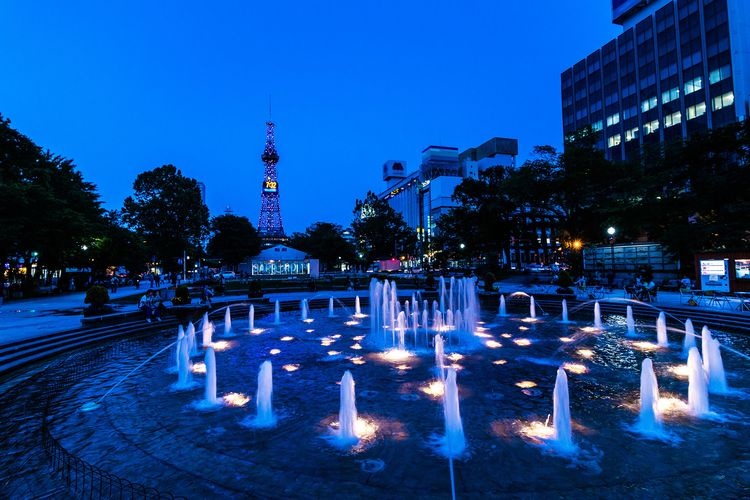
<box><xmin>289</xmin><ymin>222</ymin><xmax>355</xmax><ymax>271</ymax></box>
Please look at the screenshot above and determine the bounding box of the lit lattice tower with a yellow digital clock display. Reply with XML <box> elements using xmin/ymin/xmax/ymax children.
<box><xmin>258</xmin><ymin>121</ymin><xmax>287</xmax><ymax>244</ymax></box>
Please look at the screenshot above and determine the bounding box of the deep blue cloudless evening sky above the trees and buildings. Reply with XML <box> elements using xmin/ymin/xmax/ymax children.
<box><xmin>0</xmin><ymin>0</ymin><xmax>620</xmax><ymax>233</ymax></box>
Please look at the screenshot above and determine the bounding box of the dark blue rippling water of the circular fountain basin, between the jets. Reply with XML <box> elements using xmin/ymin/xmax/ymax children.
<box><xmin>0</xmin><ymin>306</ymin><xmax>750</xmax><ymax>498</ymax></box>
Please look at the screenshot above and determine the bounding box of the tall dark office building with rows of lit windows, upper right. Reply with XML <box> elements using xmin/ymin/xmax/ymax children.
<box><xmin>560</xmin><ymin>0</ymin><xmax>750</xmax><ymax>160</ymax></box>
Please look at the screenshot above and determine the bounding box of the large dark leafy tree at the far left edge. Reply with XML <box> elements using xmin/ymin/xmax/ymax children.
<box><xmin>0</xmin><ymin>115</ymin><xmax>102</xmax><ymax>286</ymax></box>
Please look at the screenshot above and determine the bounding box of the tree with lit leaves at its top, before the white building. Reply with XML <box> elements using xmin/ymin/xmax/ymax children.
<box><xmin>352</xmin><ymin>191</ymin><xmax>417</xmax><ymax>262</ymax></box>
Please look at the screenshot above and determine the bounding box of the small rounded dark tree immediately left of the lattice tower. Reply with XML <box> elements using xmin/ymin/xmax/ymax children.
<box><xmin>207</xmin><ymin>214</ymin><xmax>261</xmax><ymax>269</ymax></box>
